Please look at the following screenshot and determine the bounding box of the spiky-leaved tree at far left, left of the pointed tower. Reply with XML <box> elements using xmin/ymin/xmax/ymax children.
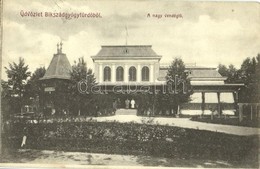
<box><xmin>5</xmin><ymin>57</ymin><xmax>31</xmax><ymax>114</ymax></box>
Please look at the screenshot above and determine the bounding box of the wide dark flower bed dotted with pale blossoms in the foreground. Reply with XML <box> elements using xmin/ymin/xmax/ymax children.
<box><xmin>5</xmin><ymin>121</ymin><xmax>258</xmax><ymax>166</ymax></box>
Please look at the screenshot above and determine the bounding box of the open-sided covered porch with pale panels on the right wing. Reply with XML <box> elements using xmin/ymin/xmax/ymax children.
<box><xmin>180</xmin><ymin>84</ymin><xmax>243</xmax><ymax>116</ymax></box>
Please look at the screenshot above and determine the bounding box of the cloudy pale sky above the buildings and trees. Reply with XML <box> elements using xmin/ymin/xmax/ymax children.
<box><xmin>2</xmin><ymin>0</ymin><xmax>260</xmax><ymax>79</ymax></box>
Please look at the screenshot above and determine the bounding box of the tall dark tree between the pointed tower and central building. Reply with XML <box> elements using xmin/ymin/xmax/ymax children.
<box><xmin>70</xmin><ymin>58</ymin><xmax>96</xmax><ymax>115</ymax></box>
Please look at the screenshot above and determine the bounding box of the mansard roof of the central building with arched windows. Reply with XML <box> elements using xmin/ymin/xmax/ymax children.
<box><xmin>92</xmin><ymin>45</ymin><xmax>161</xmax><ymax>59</ymax></box>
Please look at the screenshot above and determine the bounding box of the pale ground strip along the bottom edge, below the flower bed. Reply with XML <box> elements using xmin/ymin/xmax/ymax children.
<box><xmin>0</xmin><ymin>149</ymin><xmax>236</xmax><ymax>169</ymax></box>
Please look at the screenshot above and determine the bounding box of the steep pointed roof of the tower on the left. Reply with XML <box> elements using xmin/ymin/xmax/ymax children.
<box><xmin>41</xmin><ymin>53</ymin><xmax>72</xmax><ymax>80</ymax></box>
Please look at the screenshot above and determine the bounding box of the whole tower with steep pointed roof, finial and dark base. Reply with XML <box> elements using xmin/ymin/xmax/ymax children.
<box><xmin>40</xmin><ymin>42</ymin><xmax>72</xmax><ymax>115</ymax></box>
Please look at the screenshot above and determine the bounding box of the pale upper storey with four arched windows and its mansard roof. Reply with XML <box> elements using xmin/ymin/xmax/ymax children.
<box><xmin>92</xmin><ymin>45</ymin><xmax>162</xmax><ymax>85</ymax></box>
